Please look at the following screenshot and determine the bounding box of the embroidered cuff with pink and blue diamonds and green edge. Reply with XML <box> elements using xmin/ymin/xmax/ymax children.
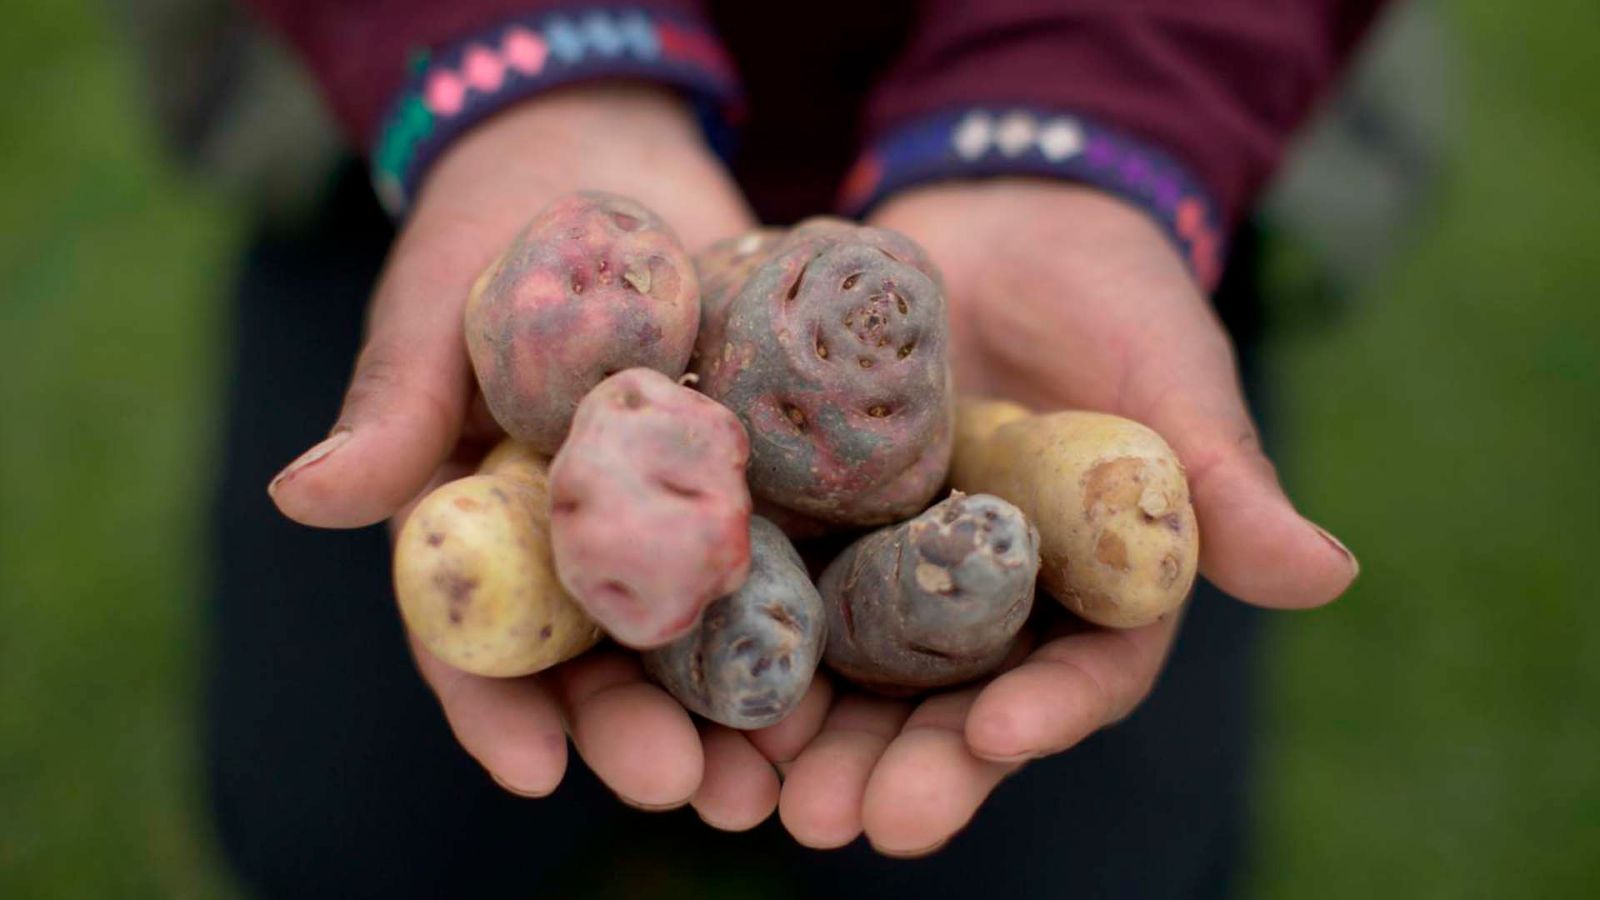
<box><xmin>371</xmin><ymin>8</ymin><xmax>739</xmax><ymax>218</ymax></box>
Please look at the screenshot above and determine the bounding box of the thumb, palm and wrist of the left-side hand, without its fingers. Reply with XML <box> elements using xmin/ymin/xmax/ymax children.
<box><xmin>267</xmin><ymin>83</ymin><xmax>761</xmax><ymax>528</ymax></box>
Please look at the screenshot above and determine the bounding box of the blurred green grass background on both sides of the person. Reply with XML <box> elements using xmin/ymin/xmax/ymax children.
<box><xmin>0</xmin><ymin>0</ymin><xmax>1600</xmax><ymax>898</ymax></box>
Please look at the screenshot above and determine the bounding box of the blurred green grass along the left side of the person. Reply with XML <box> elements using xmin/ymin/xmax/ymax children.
<box><xmin>0</xmin><ymin>0</ymin><xmax>235</xmax><ymax>897</ymax></box>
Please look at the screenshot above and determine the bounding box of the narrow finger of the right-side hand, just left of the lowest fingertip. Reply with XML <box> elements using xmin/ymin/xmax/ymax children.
<box><xmin>778</xmin><ymin>693</ymin><xmax>910</xmax><ymax>850</ymax></box>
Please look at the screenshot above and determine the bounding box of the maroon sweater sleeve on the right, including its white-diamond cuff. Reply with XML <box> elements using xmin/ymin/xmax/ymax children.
<box><xmin>843</xmin><ymin>0</ymin><xmax>1382</xmax><ymax>287</ymax></box>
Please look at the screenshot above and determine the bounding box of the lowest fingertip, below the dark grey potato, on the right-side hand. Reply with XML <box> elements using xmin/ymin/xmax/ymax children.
<box><xmin>861</xmin><ymin>689</ymin><xmax>1021</xmax><ymax>857</ymax></box>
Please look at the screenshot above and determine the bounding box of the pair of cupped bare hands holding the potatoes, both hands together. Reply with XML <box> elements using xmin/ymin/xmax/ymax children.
<box><xmin>270</xmin><ymin>85</ymin><xmax>1357</xmax><ymax>855</ymax></box>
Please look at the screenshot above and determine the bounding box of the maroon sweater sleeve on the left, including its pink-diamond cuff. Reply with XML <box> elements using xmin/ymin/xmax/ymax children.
<box><xmin>250</xmin><ymin>0</ymin><xmax>739</xmax><ymax>215</ymax></box>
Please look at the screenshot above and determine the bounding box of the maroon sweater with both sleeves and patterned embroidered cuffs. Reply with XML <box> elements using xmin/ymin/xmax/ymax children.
<box><xmin>251</xmin><ymin>0</ymin><xmax>1382</xmax><ymax>282</ymax></box>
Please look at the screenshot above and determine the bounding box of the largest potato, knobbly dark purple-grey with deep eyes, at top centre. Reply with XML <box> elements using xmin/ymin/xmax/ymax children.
<box><xmin>694</xmin><ymin>219</ymin><xmax>954</xmax><ymax>525</ymax></box>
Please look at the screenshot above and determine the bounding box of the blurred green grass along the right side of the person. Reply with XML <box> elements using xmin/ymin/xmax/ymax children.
<box><xmin>1254</xmin><ymin>0</ymin><xmax>1600</xmax><ymax>898</ymax></box>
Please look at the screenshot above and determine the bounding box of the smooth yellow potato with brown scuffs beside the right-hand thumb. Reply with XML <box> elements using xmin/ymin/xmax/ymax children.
<box><xmin>950</xmin><ymin>400</ymin><xmax>1200</xmax><ymax>628</ymax></box>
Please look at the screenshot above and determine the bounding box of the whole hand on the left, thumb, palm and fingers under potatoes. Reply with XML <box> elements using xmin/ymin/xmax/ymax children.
<box><xmin>269</xmin><ymin>83</ymin><xmax>778</xmax><ymax>828</ymax></box>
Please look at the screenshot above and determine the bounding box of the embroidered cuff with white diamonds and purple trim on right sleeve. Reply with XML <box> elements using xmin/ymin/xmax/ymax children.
<box><xmin>840</xmin><ymin>106</ymin><xmax>1224</xmax><ymax>290</ymax></box>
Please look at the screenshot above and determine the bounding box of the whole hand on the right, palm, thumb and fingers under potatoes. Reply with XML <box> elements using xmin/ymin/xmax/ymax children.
<box><xmin>768</xmin><ymin>179</ymin><xmax>1358</xmax><ymax>855</ymax></box>
